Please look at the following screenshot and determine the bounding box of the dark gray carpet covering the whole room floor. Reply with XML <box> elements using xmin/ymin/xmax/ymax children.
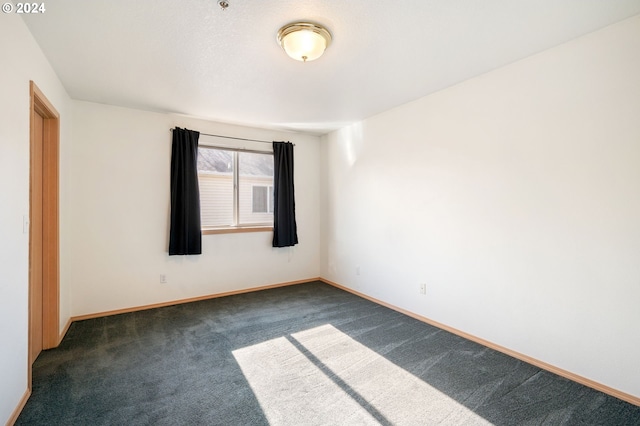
<box><xmin>16</xmin><ymin>282</ymin><xmax>640</xmax><ymax>426</ymax></box>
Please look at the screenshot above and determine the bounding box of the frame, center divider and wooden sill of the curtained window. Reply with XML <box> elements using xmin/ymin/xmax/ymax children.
<box><xmin>198</xmin><ymin>144</ymin><xmax>273</xmax><ymax>235</ymax></box>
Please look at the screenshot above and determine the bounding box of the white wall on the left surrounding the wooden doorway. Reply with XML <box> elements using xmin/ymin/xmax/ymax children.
<box><xmin>0</xmin><ymin>14</ymin><xmax>70</xmax><ymax>424</ymax></box>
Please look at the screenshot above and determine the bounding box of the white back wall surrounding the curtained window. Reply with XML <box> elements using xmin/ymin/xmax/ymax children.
<box><xmin>66</xmin><ymin>101</ymin><xmax>320</xmax><ymax>316</ymax></box>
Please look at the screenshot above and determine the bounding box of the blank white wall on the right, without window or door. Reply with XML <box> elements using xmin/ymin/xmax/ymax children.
<box><xmin>322</xmin><ymin>16</ymin><xmax>640</xmax><ymax>397</ymax></box>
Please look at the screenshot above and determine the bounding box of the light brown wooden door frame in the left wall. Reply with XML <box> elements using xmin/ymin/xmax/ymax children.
<box><xmin>28</xmin><ymin>81</ymin><xmax>60</xmax><ymax>360</ymax></box>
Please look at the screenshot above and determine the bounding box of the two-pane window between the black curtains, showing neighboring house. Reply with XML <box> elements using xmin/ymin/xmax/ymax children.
<box><xmin>198</xmin><ymin>146</ymin><xmax>273</xmax><ymax>230</ymax></box>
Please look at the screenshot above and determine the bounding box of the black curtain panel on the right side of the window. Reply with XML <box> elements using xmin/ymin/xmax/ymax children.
<box><xmin>273</xmin><ymin>142</ymin><xmax>298</xmax><ymax>247</ymax></box>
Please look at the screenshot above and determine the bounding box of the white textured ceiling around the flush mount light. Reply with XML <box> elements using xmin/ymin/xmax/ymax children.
<box><xmin>22</xmin><ymin>0</ymin><xmax>640</xmax><ymax>134</ymax></box>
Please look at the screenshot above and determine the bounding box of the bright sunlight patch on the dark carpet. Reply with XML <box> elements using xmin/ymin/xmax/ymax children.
<box><xmin>233</xmin><ymin>324</ymin><xmax>491</xmax><ymax>425</ymax></box>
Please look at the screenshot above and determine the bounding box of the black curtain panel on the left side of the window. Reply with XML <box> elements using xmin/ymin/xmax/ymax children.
<box><xmin>169</xmin><ymin>127</ymin><xmax>202</xmax><ymax>256</ymax></box>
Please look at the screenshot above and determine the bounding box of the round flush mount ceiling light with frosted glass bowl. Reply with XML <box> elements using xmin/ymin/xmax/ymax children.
<box><xmin>278</xmin><ymin>22</ymin><xmax>331</xmax><ymax>62</ymax></box>
